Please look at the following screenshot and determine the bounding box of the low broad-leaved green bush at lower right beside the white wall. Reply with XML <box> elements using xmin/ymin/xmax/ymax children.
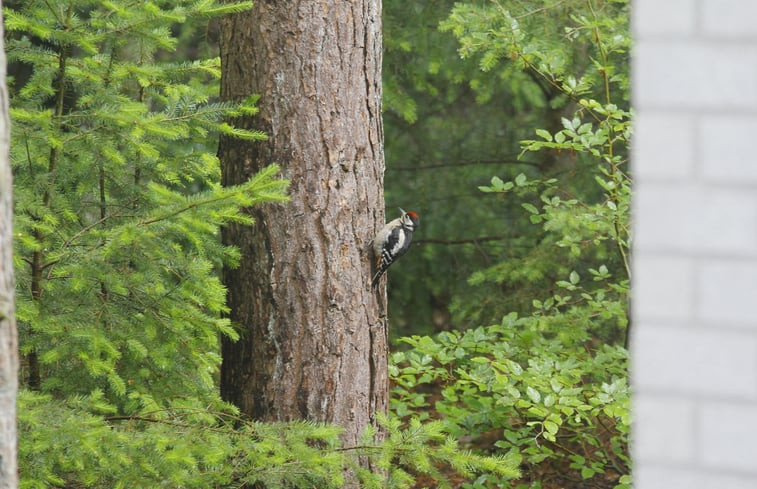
<box><xmin>391</xmin><ymin>310</ymin><xmax>630</xmax><ymax>488</ymax></box>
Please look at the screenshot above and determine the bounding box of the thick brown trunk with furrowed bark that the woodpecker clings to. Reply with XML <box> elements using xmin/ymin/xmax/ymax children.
<box><xmin>219</xmin><ymin>0</ymin><xmax>387</xmax><ymax>445</ymax></box>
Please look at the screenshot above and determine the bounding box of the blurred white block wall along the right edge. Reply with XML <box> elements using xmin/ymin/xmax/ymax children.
<box><xmin>631</xmin><ymin>0</ymin><xmax>757</xmax><ymax>489</ymax></box>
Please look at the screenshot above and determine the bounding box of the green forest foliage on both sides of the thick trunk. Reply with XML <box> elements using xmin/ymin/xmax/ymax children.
<box><xmin>5</xmin><ymin>0</ymin><xmax>630</xmax><ymax>488</ymax></box>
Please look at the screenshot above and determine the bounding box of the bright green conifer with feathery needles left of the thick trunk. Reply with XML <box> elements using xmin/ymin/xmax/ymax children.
<box><xmin>6</xmin><ymin>1</ymin><xmax>285</xmax><ymax>406</ymax></box>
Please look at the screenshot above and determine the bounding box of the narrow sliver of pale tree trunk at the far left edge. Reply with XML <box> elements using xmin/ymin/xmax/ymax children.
<box><xmin>0</xmin><ymin>2</ymin><xmax>18</xmax><ymax>489</ymax></box>
